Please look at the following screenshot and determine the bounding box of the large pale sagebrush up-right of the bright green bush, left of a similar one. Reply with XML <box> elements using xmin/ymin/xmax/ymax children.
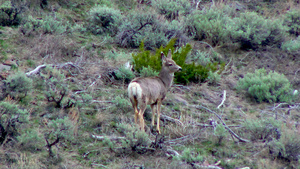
<box><xmin>185</xmin><ymin>8</ymin><xmax>233</xmax><ymax>46</ymax></box>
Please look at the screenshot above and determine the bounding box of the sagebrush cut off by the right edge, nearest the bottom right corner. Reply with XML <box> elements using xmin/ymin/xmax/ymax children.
<box><xmin>268</xmin><ymin>131</ymin><xmax>300</xmax><ymax>162</ymax></box>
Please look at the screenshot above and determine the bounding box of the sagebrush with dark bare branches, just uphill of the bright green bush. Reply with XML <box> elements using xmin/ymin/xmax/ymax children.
<box><xmin>116</xmin><ymin>11</ymin><xmax>167</xmax><ymax>49</ymax></box>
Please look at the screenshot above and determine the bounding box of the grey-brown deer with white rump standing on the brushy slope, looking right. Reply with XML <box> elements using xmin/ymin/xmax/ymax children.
<box><xmin>128</xmin><ymin>50</ymin><xmax>182</xmax><ymax>134</ymax></box>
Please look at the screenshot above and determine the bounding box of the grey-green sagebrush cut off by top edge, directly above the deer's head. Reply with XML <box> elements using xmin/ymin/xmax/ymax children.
<box><xmin>152</xmin><ymin>0</ymin><xmax>191</xmax><ymax>20</ymax></box>
